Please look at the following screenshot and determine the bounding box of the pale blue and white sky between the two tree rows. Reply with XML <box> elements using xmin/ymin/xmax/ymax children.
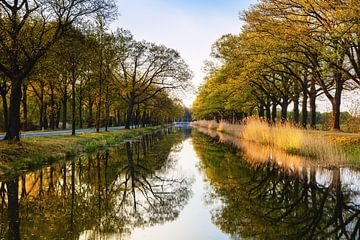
<box><xmin>111</xmin><ymin>0</ymin><xmax>256</xmax><ymax>106</ymax></box>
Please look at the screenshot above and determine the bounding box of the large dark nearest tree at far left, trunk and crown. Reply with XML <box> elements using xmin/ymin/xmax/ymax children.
<box><xmin>0</xmin><ymin>0</ymin><xmax>115</xmax><ymax>140</ymax></box>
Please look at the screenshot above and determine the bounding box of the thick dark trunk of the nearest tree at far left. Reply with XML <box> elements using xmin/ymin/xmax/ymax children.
<box><xmin>4</xmin><ymin>78</ymin><xmax>22</xmax><ymax>141</ymax></box>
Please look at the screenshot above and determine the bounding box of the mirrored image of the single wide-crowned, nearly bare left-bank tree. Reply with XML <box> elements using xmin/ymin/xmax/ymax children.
<box><xmin>114</xmin><ymin>143</ymin><xmax>189</xmax><ymax>226</ymax></box>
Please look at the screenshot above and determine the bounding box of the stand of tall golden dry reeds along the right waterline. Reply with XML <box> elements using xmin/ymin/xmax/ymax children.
<box><xmin>194</xmin><ymin>119</ymin><xmax>346</xmax><ymax>166</ymax></box>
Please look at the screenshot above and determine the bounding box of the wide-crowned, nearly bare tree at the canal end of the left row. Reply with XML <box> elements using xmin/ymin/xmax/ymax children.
<box><xmin>115</xmin><ymin>29</ymin><xmax>191</xmax><ymax>128</ymax></box>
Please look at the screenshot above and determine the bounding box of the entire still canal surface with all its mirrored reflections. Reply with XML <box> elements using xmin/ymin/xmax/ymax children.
<box><xmin>0</xmin><ymin>128</ymin><xmax>360</xmax><ymax>240</ymax></box>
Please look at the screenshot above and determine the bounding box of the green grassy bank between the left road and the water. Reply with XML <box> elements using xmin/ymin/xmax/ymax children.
<box><xmin>0</xmin><ymin>126</ymin><xmax>163</xmax><ymax>174</ymax></box>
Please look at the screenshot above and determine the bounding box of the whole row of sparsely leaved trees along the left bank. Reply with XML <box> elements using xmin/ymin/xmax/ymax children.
<box><xmin>0</xmin><ymin>0</ymin><xmax>191</xmax><ymax>140</ymax></box>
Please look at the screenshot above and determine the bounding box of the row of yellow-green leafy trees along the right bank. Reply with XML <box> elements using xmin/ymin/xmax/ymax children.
<box><xmin>193</xmin><ymin>0</ymin><xmax>360</xmax><ymax>129</ymax></box>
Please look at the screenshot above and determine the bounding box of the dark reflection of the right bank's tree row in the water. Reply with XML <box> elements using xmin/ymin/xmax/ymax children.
<box><xmin>193</xmin><ymin>130</ymin><xmax>360</xmax><ymax>239</ymax></box>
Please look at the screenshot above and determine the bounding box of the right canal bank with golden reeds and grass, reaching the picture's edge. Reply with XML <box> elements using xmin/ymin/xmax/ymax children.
<box><xmin>195</xmin><ymin>119</ymin><xmax>360</xmax><ymax>166</ymax></box>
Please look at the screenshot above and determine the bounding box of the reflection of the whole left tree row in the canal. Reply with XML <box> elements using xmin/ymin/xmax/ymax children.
<box><xmin>0</xmin><ymin>129</ymin><xmax>190</xmax><ymax>239</ymax></box>
